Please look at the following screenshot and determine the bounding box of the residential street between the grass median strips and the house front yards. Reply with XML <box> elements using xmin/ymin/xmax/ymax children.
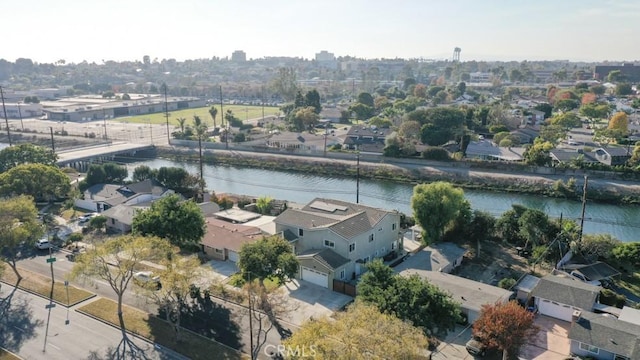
<box><xmin>13</xmin><ymin>250</ymin><xmax>287</xmax><ymax>359</ymax></box>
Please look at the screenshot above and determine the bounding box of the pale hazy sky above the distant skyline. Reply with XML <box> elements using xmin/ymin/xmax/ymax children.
<box><xmin>6</xmin><ymin>0</ymin><xmax>640</xmax><ymax>63</ymax></box>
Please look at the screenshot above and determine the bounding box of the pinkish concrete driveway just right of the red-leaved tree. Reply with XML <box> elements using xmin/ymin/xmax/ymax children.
<box><xmin>520</xmin><ymin>315</ymin><xmax>571</xmax><ymax>360</ymax></box>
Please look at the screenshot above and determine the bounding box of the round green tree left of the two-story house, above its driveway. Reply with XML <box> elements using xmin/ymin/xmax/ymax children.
<box><xmin>238</xmin><ymin>235</ymin><xmax>298</xmax><ymax>287</ymax></box>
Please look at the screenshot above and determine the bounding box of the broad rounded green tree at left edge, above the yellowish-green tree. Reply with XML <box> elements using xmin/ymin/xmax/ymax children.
<box><xmin>0</xmin><ymin>164</ymin><xmax>71</xmax><ymax>201</ymax></box>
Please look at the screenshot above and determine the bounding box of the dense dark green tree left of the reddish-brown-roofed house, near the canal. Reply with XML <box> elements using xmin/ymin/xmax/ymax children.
<box><xmin>131</xmin><ymin>194</ymin><xmax>205</xmax><ymax>248</ymax></box>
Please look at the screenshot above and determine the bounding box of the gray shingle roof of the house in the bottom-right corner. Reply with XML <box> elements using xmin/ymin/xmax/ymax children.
<box><xmin>569</xmin><ymin>311</ymin><xmax>640</xmax><ymax>359</ymax></box>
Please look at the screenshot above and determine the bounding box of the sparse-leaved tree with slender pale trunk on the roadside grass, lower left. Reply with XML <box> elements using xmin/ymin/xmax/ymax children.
<box><xmin>69</xmin><ymin>235</ymin><xmax>168</xmax><ymax>359</ymax></box>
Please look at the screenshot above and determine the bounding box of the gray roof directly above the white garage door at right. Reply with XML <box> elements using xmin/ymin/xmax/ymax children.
<box><xmin>531</xmin><ymin>275</ymin><xmax>600</xmax><ymax>311</ymax></box>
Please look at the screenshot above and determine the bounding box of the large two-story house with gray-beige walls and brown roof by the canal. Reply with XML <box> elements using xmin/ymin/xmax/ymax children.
<box><xmin>274</xmin><ymin>198</ymin><xmax>401</xmax><ymax>289</ymax></box>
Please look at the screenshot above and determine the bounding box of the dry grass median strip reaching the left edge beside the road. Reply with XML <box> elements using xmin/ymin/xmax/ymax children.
<box><xmin>2</xmin><ymin>268</ymin><xmax>93</xmax><ymax>306</ymax></box>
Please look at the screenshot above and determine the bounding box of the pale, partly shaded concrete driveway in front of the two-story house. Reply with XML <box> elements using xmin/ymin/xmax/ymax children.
<box><xmin>280</xmin><ymin>280</ymin><xmax>353</xmax><ymax>326</ymax></box>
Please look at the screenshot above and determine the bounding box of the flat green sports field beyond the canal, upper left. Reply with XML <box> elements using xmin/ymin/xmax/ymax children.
<box><xmin>112</xmin><ymin>104</ymin><xmax>280</xmax><ymax>127</ymax></box>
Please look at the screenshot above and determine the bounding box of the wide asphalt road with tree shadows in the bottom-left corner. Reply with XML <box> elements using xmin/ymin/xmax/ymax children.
<box><xmin>0</xmin><ymin>284</ymin><xmax>182</xmax><ymax>360</ymax></box>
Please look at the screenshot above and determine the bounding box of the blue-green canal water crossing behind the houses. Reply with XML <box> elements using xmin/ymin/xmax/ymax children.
<box><xmin>127</xmin><ymin>159</ymin><xmax>640</xmax><ymax>241</ymax></box>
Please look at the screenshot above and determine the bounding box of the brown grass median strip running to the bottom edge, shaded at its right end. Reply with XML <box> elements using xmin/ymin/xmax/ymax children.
<box><xmin>78</xmin><ymin>299</ymin><xmax>242</xmax><ymax>359</ymax></box>
